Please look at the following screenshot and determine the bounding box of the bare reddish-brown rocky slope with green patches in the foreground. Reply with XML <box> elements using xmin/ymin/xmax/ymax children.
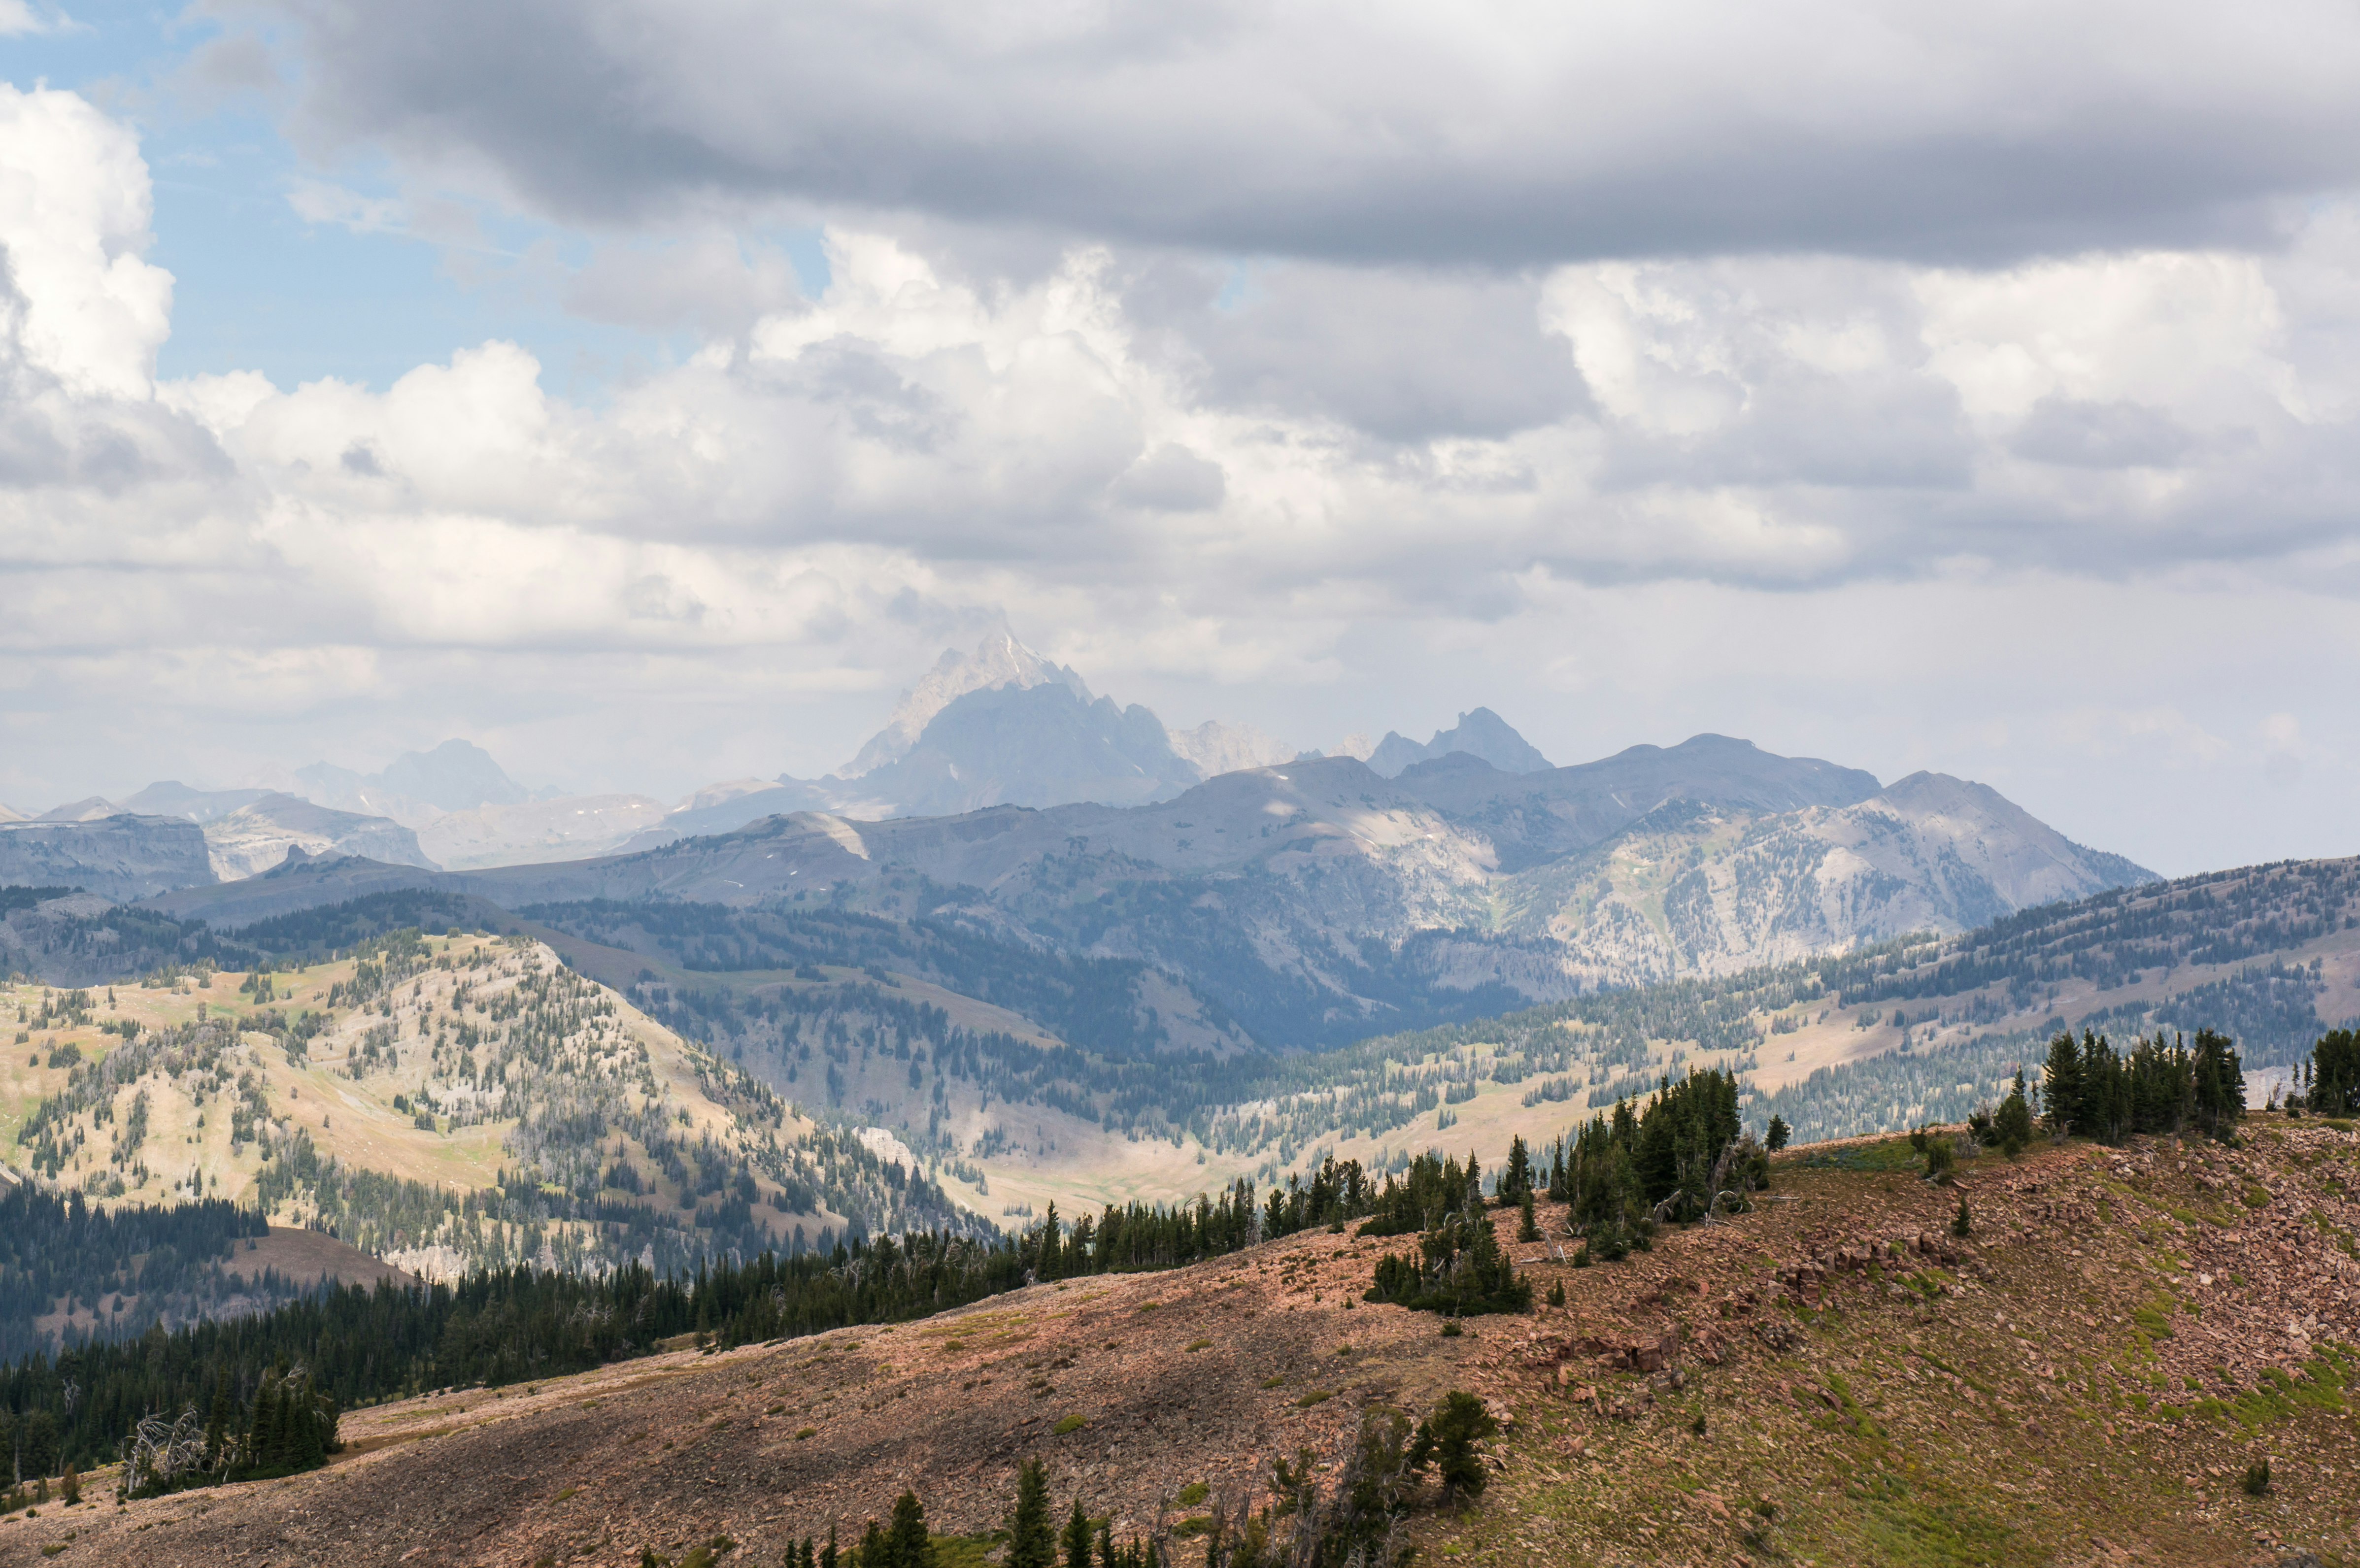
<box><xmin>0</xmin><ymin>1115</ymin><xmax>2360</xmax><ymax>1568</ymax></box>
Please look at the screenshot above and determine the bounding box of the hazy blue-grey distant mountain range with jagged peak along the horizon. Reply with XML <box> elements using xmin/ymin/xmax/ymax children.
<box><xmin>0</xmin><ymin>632</ymin><xmax>2152</xmax><ymax>1028</ymax></box>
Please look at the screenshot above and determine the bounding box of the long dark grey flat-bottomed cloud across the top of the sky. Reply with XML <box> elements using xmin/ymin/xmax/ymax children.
<box><xmin>249</xmin><ymin>0</ymin><xmax>2360</xmax><ymax>267</ymax></box>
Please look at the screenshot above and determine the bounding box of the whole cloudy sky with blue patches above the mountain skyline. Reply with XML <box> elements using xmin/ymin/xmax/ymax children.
<box><xmin>0</xmin><ymin>0</ymin><xmax>2360</xmax><ymax>875</ymax></box>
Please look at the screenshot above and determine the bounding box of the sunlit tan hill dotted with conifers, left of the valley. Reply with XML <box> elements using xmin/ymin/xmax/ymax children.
<box><xmin>0</xmin><ymin>910</ymin><xmax>977</xmax><ymax>1301</ymax></box>
